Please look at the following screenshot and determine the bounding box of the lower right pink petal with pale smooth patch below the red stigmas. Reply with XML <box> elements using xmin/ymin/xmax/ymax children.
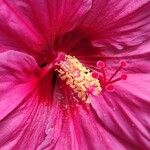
<box><xmin>91</xmin><ymin>73</ymin><xmax>150</xmax><ymax>149</ymax></box>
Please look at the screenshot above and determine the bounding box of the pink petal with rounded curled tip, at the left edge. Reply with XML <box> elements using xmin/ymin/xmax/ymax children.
<box><xmin>0</xmin><ymin>51</ymin><xmax>37</xmax><ymax>119</ymax></box>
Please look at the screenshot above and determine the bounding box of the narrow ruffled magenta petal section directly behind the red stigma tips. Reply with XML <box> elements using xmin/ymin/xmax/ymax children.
<box><xmin>83</xmin><ymin>42</ymin><xmax>150</xmax><ymax>75</ymax></box>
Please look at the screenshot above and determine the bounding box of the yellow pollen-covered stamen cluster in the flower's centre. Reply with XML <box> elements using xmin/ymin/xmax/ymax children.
<box><xmin>56</xmin><ymin>55</ymin><xmax>101</xmax><ymax>101</ymax></box>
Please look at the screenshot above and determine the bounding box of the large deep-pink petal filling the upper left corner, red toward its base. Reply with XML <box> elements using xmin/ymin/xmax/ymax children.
<box><xmin>0</xmin><ymin>0</ymin><xmax>92</xmax><ymax>65</ymax></box>
